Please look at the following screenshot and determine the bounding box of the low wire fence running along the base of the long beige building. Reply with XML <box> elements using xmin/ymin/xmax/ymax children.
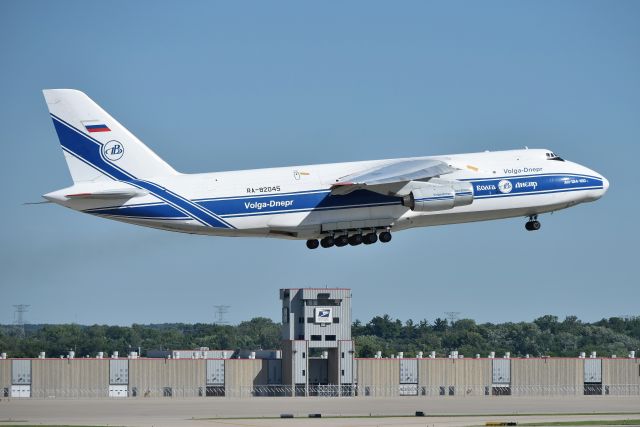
<box><xmin>8</xmin><ymin>384</ymin><xmax>640</xmax><ymax>399</ymax></box>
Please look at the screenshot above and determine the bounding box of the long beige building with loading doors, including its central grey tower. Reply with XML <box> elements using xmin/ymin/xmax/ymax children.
<box><xmin>0</xmin><ymin>288</ymin><xmax>640</xmax><ymax>399</ymax></box>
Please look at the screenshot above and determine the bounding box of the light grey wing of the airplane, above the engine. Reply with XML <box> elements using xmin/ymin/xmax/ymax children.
<box><xmin>331</xmin><ymin>159</ymin><xmax>457</xmax><ymax>195</ymax></box>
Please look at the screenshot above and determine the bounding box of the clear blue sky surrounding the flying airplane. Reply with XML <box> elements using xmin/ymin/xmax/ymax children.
<box><xmin>0</xmin><ymin>0</ymin><xmax>640</xmax><ymax>325</ymax></box>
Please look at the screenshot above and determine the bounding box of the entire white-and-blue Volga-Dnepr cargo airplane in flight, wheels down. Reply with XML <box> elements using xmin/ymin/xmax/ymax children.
<box><xmin>43</xmin><ymin>89</ymin><xmax>609</xmax><ymax>249</ymax></box>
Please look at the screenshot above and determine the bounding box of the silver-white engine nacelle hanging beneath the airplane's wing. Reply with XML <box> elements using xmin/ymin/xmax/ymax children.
<box><xmin>402</xmin><ymin>178</ymin><xmax>473</xmax><ymax>212</ymax></box>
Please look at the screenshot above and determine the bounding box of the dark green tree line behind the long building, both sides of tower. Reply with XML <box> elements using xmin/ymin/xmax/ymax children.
<box><xmin>0</xmin><ymin>315</ymin><xmax>640</xmax><ymax>357</ymax></box>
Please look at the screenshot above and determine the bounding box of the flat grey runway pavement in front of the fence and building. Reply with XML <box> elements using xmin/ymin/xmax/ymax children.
<box><xmin>0</xmin><ymin>396</ymin><xmax>640</xmax><ymax>427</ymax></box>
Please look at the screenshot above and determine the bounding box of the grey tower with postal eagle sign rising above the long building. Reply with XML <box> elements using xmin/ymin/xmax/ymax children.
<box><xmin>280</xmin><ymin>288</ymin><xmax>354</xmax><ymax>396</ymax></box>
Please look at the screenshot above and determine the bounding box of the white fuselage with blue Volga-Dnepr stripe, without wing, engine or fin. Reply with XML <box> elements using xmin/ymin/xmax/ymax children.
<box><xmin>45</xmin><ymin>149</ymin><xmax>609</xmax><ymax>239</ymax></box>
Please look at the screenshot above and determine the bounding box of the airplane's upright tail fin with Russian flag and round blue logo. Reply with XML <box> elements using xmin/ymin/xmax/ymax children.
<box><xmin>43</xmin><ymin>89</ymin><xmax>177</xmax><ymax>183</ymax></box>
